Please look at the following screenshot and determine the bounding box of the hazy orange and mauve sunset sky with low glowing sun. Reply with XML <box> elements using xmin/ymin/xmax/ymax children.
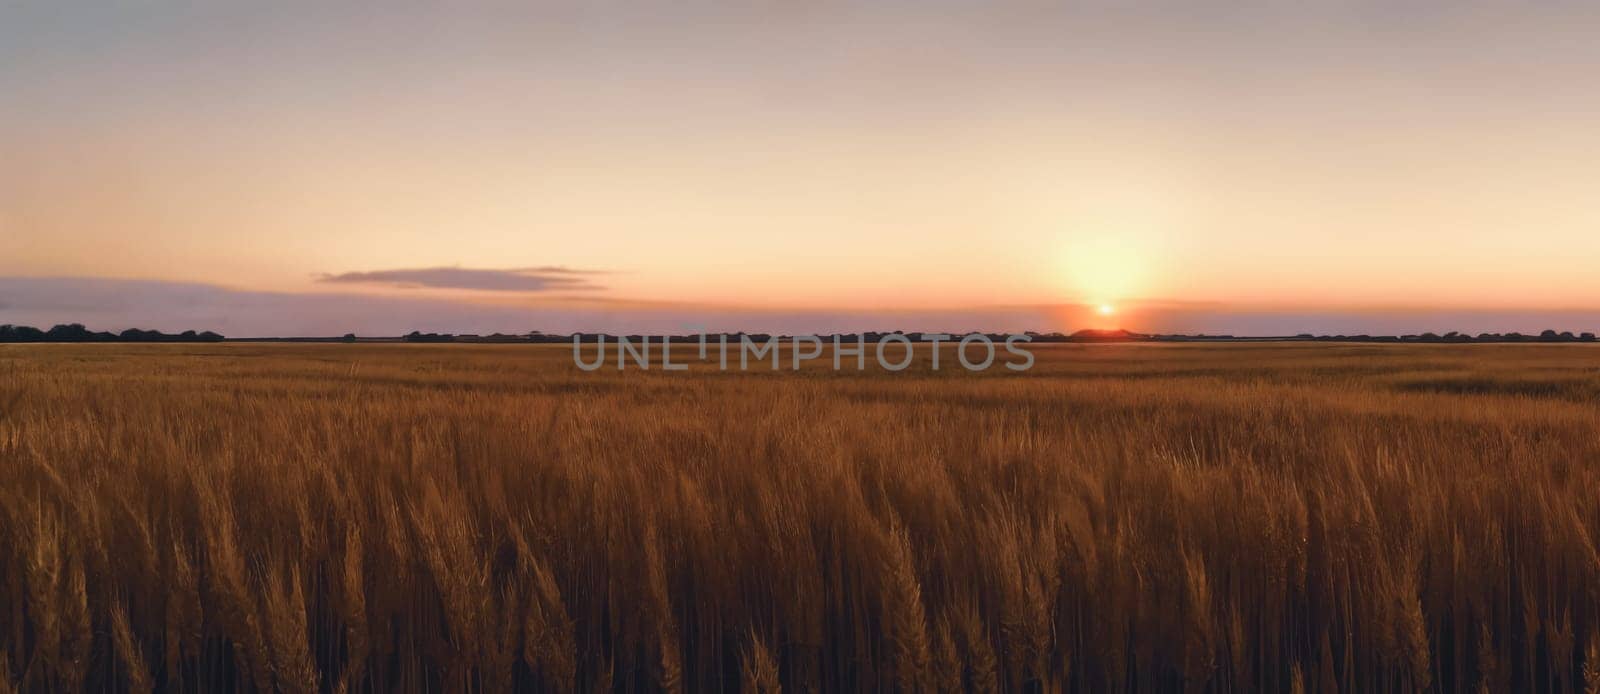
<box><xmin>0</xmin><ymin>0</ymin><xmax>1600</xmax><ymax>336</ymax></box>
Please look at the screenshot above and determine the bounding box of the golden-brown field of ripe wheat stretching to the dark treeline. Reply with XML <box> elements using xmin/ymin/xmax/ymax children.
<box><xmin>0</xmin><ymin>344</ymin><xmax>1600</xmax><ymax>692</ymax></box>
